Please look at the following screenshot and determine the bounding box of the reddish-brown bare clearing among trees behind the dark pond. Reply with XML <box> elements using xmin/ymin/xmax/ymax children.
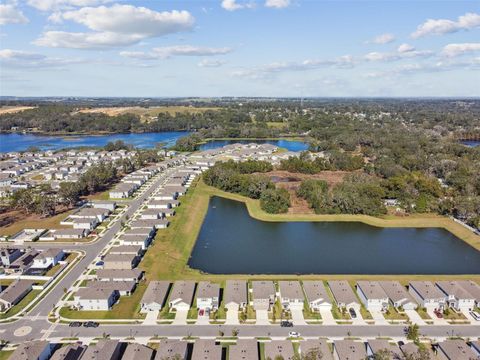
<box><xmin>266</xmin><ymin>170</ymin><xmax>349</xmax><ymax>214</ymax></box>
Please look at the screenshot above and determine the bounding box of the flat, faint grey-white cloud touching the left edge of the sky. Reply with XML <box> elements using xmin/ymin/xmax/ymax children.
<box><xmin>0</xmin><ymin>49</ymin><xmax>84</xmax><ymax>68</ymax></box>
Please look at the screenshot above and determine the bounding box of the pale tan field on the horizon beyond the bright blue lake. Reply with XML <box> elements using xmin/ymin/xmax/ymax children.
<box><xmin>77</xmin><ymin>106</ymin><xmax>219</xmax><ymax>121</ymax></box>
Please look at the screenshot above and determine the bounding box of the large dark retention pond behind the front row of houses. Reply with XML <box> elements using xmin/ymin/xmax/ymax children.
<box><xmin>188</xmin><ymin>197</ymin><xmax>480</xmax><ymax>274</ymax></box>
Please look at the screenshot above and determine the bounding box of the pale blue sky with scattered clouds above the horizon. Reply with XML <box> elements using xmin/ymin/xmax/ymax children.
<box><xmin>0</xmin><ymin>0</ymin><xmax>480</xmax><ymax>97</ymax></box>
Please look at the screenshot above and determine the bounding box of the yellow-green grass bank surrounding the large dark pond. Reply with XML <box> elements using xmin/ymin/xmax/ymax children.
<box><xmin>140</xmin><ymin>180</ymin><xmax>480</xmax><ymax>284</ymax></box>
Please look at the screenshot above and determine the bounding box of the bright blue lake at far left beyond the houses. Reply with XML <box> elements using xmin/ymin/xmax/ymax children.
<box><xmin>0</xmin><ymin>131</ymin><xmax>188</xmax><ymax>152</ymax></box>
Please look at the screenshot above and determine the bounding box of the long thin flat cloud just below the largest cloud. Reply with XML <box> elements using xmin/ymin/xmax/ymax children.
<box><xmin>120</xmin><ymin>45</ymin><xmax>232</xmax><ymax>60</ymax></box>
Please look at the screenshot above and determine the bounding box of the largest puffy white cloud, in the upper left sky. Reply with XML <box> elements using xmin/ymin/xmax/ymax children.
<box><xmin>34</xmin><ymin>4</ymin><xmax>195</xmax><ymax>49</ymax></box>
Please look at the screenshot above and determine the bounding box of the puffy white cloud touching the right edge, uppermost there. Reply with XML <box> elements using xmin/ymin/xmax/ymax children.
<box><xmin>411</xmin><ymin>13</ymin><xmax>480</xmax><ymax>38</ymax></box>
